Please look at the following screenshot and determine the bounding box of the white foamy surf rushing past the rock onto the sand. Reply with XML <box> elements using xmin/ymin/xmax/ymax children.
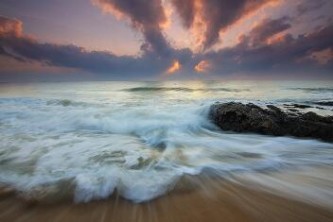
<box><xmin>0</xmin><ymin>85</ymin><xmax>333</xmax><ymax>202</ymax></box>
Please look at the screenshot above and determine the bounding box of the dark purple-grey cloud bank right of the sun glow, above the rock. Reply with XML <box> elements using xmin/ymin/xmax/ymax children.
<box><xmin>206</xmin><ymin>18</ymin><xmax>333</xmax><ymax>73</ymax></box>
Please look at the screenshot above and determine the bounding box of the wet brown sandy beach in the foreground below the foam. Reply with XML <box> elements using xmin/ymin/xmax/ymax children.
<box><xmin>0</xmin><ymin>168</ymin><xmax>333</xmax><ymax>222</ymax></box>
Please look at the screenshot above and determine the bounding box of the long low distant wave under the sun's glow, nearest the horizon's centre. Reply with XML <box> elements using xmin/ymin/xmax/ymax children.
<box><xmin>125</xmin><ymin>87</ymin><xmax>250</xmax><ymax>92</ymax></box>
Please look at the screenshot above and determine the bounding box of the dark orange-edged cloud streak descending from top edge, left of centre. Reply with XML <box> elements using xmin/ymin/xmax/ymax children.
<box><xmin>94</xmin><ymin>0</ymin><xmax>170</xmax><ymax>55</ymax></box>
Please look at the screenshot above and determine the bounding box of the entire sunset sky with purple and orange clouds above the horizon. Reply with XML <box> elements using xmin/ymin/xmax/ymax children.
<box><xmin>0</xmin><ymin>0</ymin><xmax>333</xmax><ymax>82</ymax></box>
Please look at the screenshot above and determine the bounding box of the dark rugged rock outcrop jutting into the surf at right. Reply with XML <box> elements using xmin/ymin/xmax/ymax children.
<box><xmin>209</xmin><ymin>102</ymin><xmax>333</xmax><ymax>141</ymax></box>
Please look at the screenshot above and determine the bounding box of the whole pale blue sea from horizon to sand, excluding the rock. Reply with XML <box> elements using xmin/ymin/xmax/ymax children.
<box><xmin>0</xmin><ymin>81</ymin><xmax>333</xmax><ymax>202</ymax></box>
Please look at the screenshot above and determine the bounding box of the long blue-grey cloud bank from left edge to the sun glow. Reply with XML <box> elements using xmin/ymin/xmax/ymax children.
<box><xmin>0</xmin><ymin>16</ymin><xmax>174</xmax><ymax>78</ymax></box>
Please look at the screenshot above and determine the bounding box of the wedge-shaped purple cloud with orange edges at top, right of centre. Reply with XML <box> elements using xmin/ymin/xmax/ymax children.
<box><xmin>172</xmin><ymin>0</ymin><xmax>277</xmax><ymax>50</ymax></box>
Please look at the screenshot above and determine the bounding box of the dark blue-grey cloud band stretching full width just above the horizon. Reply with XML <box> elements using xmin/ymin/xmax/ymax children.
<box><xmin>0</xmin><ymin>16</ymin><xmax>333</xmax><ymax>79</ymax></box>
